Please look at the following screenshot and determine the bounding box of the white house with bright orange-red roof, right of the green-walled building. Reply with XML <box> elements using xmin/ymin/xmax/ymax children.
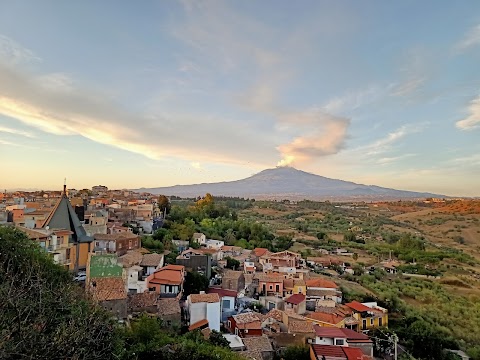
<box><xmin>147</xmin><ymin>265</ymin><xmax>186</xmax><ymax>298</ymax></box>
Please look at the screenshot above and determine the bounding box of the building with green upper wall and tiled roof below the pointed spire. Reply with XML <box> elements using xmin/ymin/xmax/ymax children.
<box><xmin>85</xmin><ymin>254</ymin><xmax>127</xmax><ymax>319</ymax></box>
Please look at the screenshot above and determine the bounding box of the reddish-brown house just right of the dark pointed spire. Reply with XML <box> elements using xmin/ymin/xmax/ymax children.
<box><xmin>93</xmin><ymin>231</ymin><xmax>142</xmax><ymax>256</ymax></box>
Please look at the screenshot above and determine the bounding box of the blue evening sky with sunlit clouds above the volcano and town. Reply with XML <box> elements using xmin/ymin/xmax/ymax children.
<box><xmin>0</xmin><ymin>0</ymin><xmax>480</xmax><ymax>196</ymax></box>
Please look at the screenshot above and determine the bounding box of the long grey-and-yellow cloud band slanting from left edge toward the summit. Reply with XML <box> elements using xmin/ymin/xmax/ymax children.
<box><xmin>0</xmin><ymin>63</ymin><xmax>275</xmax><ymax>166</ymax></box>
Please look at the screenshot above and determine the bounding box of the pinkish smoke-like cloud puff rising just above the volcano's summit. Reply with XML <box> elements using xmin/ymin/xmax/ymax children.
<box><xmin>277</xmin><ymin>109</ymin><xmax>350</xmax><ymax>166</ymax></box>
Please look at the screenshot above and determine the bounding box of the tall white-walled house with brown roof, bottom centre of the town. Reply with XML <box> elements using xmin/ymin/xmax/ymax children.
<box><xmin>187</xmin><ymin>293</ymin><xmax>221</xmax><ymax>331</ymax></box>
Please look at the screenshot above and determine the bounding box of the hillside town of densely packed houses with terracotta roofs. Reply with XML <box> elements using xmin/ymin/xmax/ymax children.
<box><xmin>0</xmin><ymin>186</ymin><xmax>396</xmax><ymax>360</ymax></box>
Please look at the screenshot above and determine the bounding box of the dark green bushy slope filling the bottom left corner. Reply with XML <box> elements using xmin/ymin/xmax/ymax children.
<box><xmin>0</xmin><ymin>226</ymin><xmax>121</xmax><ymax>359</ymax></box>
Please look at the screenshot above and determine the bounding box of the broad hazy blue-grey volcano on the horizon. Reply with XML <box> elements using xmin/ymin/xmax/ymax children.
<box><xmin>135</xmin><ymin>167</ymin><xmax>445</xmax><ymax>200</ymax></box>
